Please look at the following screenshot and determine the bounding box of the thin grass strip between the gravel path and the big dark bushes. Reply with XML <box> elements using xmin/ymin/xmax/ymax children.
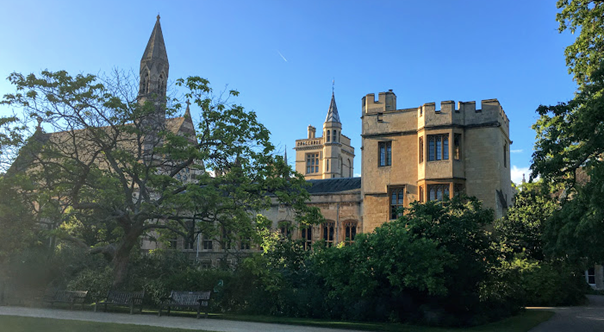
<box><xmin>216</xmin><ymin>310</ymin><xmax>554</xmax><ymax>332</ymax></box>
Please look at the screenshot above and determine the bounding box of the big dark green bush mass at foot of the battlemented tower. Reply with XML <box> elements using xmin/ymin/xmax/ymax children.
<box><xmin>254</xmin><ymin>198</ymin><xmax>515</xmax><ymax>326</ymax></box>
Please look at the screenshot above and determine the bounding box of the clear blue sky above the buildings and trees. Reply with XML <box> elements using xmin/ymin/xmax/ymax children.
<box><xmin>0</xmin><ymin>0</ymin><xmax>575</xmax><ymax>181</ymax></box>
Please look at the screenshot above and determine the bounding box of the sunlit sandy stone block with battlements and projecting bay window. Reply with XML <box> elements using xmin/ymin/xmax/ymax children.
<box><xmin>361</xmin><ymin>90</ymin><xmax>512</xmax><ymax>232</ymax></box>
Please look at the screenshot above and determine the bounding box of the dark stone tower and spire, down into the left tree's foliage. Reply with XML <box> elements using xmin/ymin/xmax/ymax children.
<box><xmin>138</xmin><ymin>15</ymin><xmax>170</xmax><ymax>129</ymax></box>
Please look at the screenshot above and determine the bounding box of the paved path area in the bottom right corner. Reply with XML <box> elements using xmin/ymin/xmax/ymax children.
<box><xmin>529</xmin><ymin>295</ymin><xmax>604</xmax><ymax>332</ymax></box>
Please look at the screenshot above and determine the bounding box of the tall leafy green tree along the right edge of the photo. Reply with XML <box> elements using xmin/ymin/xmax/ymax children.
<box><xmin>531</xmin><ymin>0</ymin><xmax>604</xmax><ymax>262</ymax></box>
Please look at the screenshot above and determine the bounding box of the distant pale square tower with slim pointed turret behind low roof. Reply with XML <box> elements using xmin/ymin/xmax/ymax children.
<box><xmin>295</xmin><ymin>91</ymin><xmax>354</xmax><ymax>180</ymax></box>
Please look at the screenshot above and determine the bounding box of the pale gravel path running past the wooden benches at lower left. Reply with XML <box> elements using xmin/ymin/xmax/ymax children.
<box><xmin>0</xmin><ymin>306</ymin><xmax>366</xmax><ymax>332</ymax></box>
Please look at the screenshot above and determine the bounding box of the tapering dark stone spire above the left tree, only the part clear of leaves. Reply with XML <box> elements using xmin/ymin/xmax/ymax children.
<box><xmin>138</xmin><ymin>15</ymin><xmax>170</xmax><ymax>99</ymax></box>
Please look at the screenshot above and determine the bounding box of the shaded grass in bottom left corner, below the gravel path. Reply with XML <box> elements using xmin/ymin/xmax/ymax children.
<box><xmin>0</xmin><ymin>316</ymin><xmax>218</xmax><ymax>332</ymax></box>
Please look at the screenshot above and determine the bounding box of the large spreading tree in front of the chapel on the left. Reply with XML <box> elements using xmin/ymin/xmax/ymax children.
<box><xmin>2</xmin><ymin>71</ymin><xmax>319</xmax><ymax>285</ymax></box>
